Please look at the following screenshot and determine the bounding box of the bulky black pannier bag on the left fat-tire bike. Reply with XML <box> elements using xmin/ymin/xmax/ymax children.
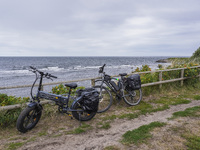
<box><xmin>77</xmin><ymin>88</ymin><xmax>99</xmax><ymax>113</ymax></box>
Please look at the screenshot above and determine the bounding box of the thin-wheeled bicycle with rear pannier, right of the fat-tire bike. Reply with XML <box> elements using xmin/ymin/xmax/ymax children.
<box><xmin>94</xmin><ymin>64</ymin><xmax>142</xmax><ymax>113</ymax></box>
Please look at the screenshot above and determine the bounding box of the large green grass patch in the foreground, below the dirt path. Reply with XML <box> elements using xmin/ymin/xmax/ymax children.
<box><xmin>121</xmin><ymin>122</ymin><xmax>166</xmax><ymax>145</ymax></box>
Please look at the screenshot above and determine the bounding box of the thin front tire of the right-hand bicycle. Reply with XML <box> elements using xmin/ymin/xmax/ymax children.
<box><xmin>94</xmin><ymin>85</ymin><xmax>113</xmax><ymax>113</ymax></box>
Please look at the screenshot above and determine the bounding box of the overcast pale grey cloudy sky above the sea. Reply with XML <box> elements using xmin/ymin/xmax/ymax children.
<box><xmin>0</xmin><ymin>0</ymin><xmax>200</xmax><ymax>56</ymax></box>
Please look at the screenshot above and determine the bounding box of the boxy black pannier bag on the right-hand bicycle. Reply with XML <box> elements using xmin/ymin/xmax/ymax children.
<box><xmin>126</xmin><ymin>74</ymin><xmax>141</xmax><ymax>90</ymax></box>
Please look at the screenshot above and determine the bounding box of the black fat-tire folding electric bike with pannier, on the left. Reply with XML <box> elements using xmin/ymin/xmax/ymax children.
<box><xmin>17</xmin><ymin>67</ymin><xmax>99</xmax><ymax>133</ymax></box>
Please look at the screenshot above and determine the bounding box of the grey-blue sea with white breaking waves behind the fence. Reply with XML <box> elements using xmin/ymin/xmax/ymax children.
<box><xmin>0</xmin><ymin>57</ymin><xmax>169</xmax><ymax>97</ymax></box>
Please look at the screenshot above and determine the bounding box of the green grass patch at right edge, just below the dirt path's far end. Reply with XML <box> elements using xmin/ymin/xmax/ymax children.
<box><xmin>169</xmin><ymin>106</ymin><xmax>200</xmax><ymax>119</ymax></box>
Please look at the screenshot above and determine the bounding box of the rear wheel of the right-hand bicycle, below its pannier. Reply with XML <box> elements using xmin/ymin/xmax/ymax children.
<box><xmin>123</xmin><ymin>89</ymin><xmax>142</xmax><ymax>106</ymax></box>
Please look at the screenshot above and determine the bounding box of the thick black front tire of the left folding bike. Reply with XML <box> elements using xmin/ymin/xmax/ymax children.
<box><xmin>17</xmin><ymin>107</ymin><xmax>42</xmax><ymax>133</ymax></box>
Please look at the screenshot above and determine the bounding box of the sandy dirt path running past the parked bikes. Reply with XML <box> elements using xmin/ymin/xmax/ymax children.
<box><xmin>20</xmin><ymin>101</ymin><xmax>200</xmax><ymax>150</ymax></box>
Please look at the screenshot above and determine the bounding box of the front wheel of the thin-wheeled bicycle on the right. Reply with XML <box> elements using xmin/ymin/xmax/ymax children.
<box><xmin>94</xmin><ymin>85</ymin><xmax>113</xmax><ymax>113</ymax></box>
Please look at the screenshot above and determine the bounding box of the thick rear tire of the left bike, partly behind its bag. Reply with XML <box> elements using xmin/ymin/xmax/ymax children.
<box><xmin>72</xmin><ymin>102</ymin><xmax>97</xmax><ymax>121</ymax></box>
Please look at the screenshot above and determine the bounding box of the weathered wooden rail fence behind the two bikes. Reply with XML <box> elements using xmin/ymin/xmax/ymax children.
<box><xmin>0</xmin><ymin>66</ymin><xmax>200</xmax><ymax>110</ymax></box>
